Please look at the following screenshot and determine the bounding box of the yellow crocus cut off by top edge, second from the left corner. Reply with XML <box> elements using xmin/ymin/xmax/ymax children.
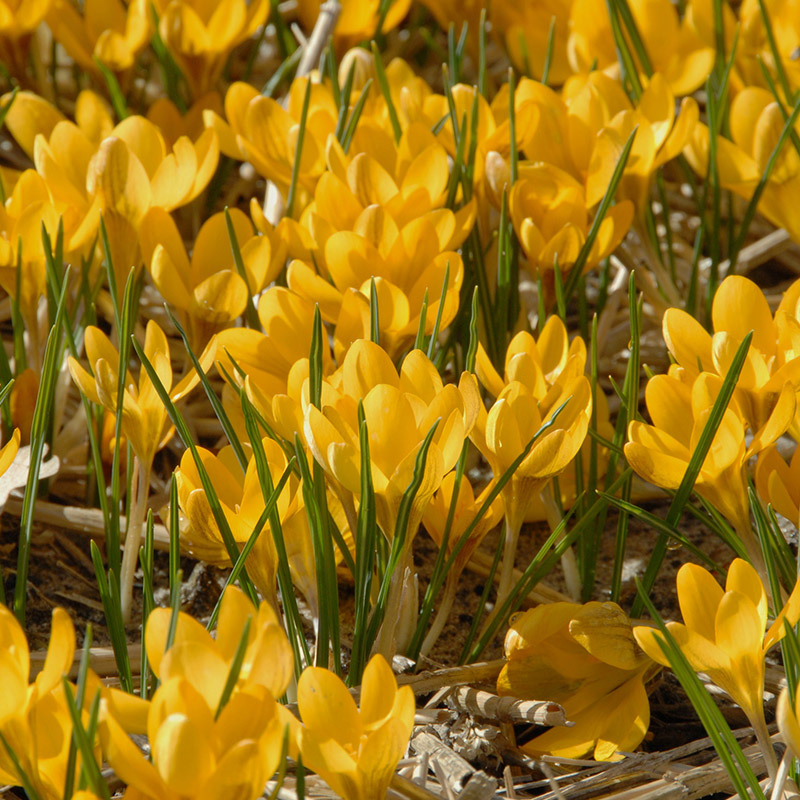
<box><xmin>47</xmin><ymin>0</ymin><xmax>152</xmax><ymax>76</ymax></box>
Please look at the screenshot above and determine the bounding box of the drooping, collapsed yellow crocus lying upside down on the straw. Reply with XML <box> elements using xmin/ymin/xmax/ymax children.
<box><xmin>497</xmin><ymin>602</ymin><xmax>657</xmax><ymax>761</ymax></box>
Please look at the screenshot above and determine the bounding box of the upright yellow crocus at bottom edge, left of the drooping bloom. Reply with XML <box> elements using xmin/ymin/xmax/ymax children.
<box><xmin>297</xmin><ymin>655</ymin><xmax>415</xmax><ymax>800</ymax></box>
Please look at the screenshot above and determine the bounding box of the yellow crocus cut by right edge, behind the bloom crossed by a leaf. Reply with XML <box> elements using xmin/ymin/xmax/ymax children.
<box><xmin>662</xmin><ymin>275</ymin><xmax>800</xmax><ymax>455</ymax></box>
